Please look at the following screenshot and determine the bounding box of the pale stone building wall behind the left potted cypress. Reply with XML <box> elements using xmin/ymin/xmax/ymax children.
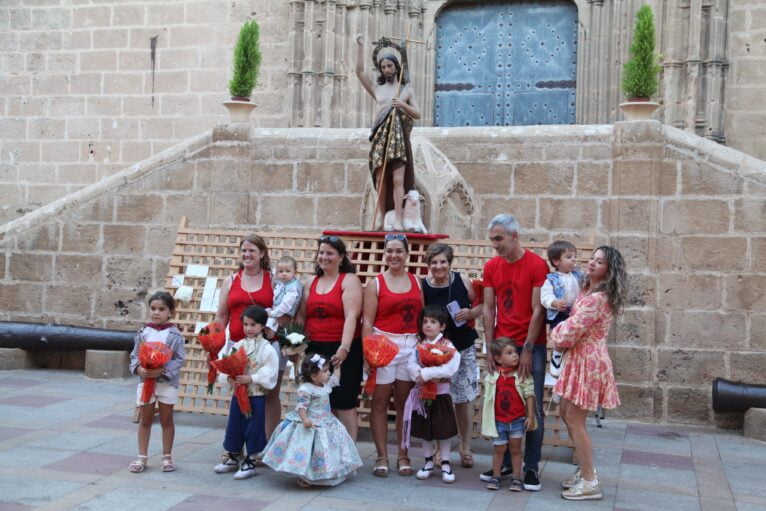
<box><xmin>0</xmin><ymin>0</ymin><xmax>288</xmax><ymax>223</ymax></box>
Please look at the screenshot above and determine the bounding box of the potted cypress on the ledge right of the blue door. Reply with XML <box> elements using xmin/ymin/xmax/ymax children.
<box><xmin>620</xmin><ymin>5</ymin><xmax>660</xmax><ymax>121</ymax></box>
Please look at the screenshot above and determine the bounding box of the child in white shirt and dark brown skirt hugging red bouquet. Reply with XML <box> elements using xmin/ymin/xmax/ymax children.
<box><xmin>404</xmin><ymin>305</ymin><xmax>460</xmax><ymax>483</ymax></box>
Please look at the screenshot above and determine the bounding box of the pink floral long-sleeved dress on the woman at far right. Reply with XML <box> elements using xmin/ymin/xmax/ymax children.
<box><xmin>549</xmin><ymin>292</ymin><xmax>620</xmax><ymax>411</ymax></box>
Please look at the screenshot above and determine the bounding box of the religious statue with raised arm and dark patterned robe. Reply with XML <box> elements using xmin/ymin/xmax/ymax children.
<box><xmin>356</xmin><ymin>34</ymin><xmax>420</xmax><ymax>231</ymax></box>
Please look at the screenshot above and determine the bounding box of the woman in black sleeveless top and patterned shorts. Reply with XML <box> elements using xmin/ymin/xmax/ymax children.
<box><xmin>423</xmin><ymin>243</ymin><xmax>482</xmax><ymax>468</ymax></box>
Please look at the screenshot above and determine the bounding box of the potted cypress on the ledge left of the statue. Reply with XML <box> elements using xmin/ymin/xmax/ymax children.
<box><xmin>223</xmin><ymin>20</ymin><xmax>261</xmax><ymax>122</ymax></box>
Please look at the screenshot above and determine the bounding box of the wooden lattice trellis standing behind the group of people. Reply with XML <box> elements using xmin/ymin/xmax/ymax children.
<box><xmin>170</xmin><ymin>217</ymin><xmax>594</xmax><ymax>446</ymax></box>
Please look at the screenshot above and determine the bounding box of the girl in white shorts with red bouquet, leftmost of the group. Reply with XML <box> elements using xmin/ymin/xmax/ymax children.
<box><xmin>129</xmin><ymin>291</ymin><xmax>186</xmax><ymax>473</ymax></box>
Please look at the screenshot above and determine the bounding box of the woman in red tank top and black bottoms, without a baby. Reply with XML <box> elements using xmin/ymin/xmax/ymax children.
<box><xmin>297</xmin><ymin>236</ymin><xmax>364</xmax><ymax>440</ymax></box>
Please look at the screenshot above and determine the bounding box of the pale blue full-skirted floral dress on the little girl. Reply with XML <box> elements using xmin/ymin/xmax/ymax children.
<box><xmin>263</xmin><ymin>373</ymin><xmax>362</xmax><ymax>486</ymax></box>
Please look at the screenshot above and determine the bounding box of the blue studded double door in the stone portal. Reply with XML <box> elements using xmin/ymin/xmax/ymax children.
<box><xmin>434</xmin><ymin>0</ymin><xmax>577</xmax><ymax>126</ymax></box>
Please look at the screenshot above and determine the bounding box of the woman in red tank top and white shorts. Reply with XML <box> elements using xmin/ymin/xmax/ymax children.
<box><xmin>362</xmin><ymin>234</ymin><xmax>423</xmax><ymax>477</ymax></box>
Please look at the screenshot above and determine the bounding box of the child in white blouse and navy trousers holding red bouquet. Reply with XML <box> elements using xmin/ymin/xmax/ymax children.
<box><xmin>214</xmin><ymin>305</ymin><xmax>279</xmax><ymax>479</ymax></box>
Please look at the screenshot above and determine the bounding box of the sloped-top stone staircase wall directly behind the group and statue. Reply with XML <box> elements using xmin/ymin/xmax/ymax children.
<box><xmin>0</xmin><ymin>122</ymin><xmax>766</xmax><ymax>424</ymax></box>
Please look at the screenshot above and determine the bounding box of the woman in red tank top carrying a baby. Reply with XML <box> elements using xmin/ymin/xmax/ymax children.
<box><xmin>215</xmin><ymin>234</ymin><xmax>289</xmax><ymax>437</ymax></box>
